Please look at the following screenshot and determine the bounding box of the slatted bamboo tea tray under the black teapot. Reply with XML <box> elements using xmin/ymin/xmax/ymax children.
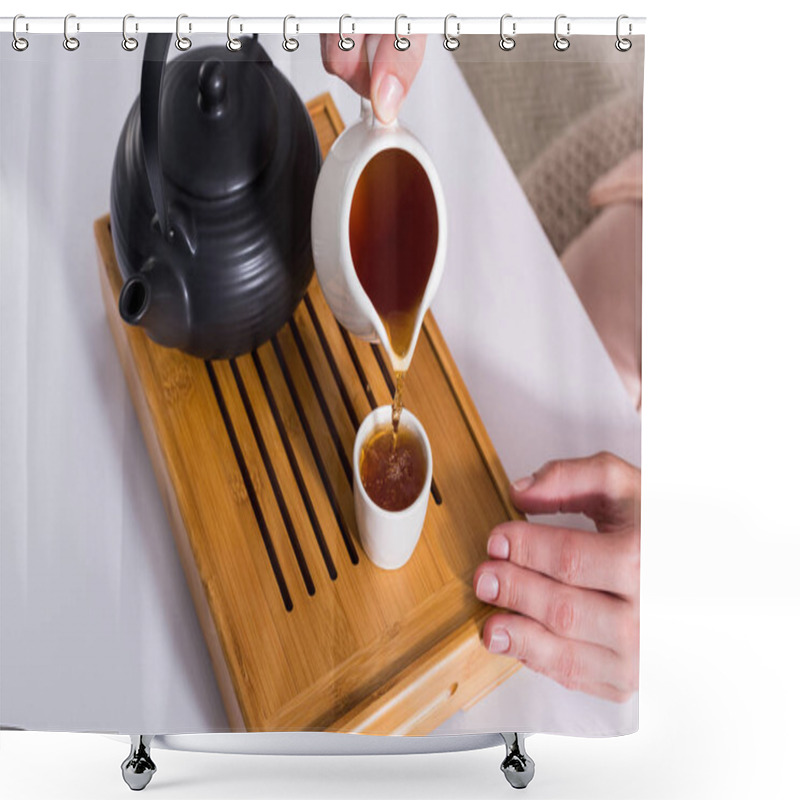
<box><xmin>95</xmin><ymin>95</ymin><xmax>518</xmax><ymax>734</ymax></box>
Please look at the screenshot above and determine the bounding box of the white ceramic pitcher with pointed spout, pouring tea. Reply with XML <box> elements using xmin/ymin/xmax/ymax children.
<box><xmin>311</xmin><ymin>99</ymin><xmax>447</xmax><ymax>371</ymax></box>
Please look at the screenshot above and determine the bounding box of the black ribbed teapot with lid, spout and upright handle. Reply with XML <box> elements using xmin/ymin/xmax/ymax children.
<box><xmin>111</xmin><ymin>33</ymin><xmax>321</xmax><ymax>358</ymax></box>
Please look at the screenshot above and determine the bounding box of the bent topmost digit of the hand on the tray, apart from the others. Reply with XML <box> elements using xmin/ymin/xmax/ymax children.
<box><xmin>509</xmin><ymin>453</ymin><xmax>641</xmax><ymax>531</ymax></box>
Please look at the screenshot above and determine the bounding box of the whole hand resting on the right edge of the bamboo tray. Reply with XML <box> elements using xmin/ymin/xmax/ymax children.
<box><xmin>474</xmin><ymin>453</ymin><xmax>641</xmax><ymax>702</ymax></box>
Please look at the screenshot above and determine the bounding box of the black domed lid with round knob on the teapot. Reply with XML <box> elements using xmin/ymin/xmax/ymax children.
<box><xmin>159</xmin><ymin>39</ymin><xmax>277</xmax><ymax>199</ymax></box>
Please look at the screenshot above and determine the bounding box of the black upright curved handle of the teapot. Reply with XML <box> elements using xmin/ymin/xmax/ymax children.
<box><xmin>139</xmin><ymin>33</ymin><xmax>171</xmax><ymax>237</ymax></box>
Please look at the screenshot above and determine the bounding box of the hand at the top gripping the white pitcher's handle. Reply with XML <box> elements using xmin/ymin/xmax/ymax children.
<box><xmin>319</xmin><ymin>33</ymin><xmax>426</xmax><ymax>123</ymax></box>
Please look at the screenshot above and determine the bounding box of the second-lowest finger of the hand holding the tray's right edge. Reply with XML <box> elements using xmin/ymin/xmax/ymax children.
<box><xmin>474</xmin><ymin>561</ymin><xmax>638</xmax><ymax>653</ymax></box>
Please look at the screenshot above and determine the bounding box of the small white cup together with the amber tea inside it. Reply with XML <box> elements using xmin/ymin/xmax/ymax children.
<box><xmin>353</xmin><ymin>406</ymin><xmax>433</xmax><ymax>569</ymax></box>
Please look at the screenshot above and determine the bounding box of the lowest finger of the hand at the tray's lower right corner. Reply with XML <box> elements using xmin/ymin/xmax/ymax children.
<box><xmin>483</xmin><ymin>614</ymin><xmax>639</xmax><ymax>702</ymax></box>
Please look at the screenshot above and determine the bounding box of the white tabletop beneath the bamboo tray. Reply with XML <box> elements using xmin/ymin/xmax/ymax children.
<box><xmin>0</xmin><ymin>35</ymin><xmax>640</xmax><ymax>735</ymax></box>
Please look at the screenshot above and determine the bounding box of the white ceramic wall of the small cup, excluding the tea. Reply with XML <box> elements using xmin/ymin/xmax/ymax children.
<box><xmin>353</xmin><ymin>406</ymin><xmax>433</xmax><ymax>569</ymax></box>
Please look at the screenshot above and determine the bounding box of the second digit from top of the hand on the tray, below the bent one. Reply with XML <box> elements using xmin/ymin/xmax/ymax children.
<box><xmin>486</xmin><ymin>521</ymin><xmax>639</xmax><ymax>597</ymax></box>
